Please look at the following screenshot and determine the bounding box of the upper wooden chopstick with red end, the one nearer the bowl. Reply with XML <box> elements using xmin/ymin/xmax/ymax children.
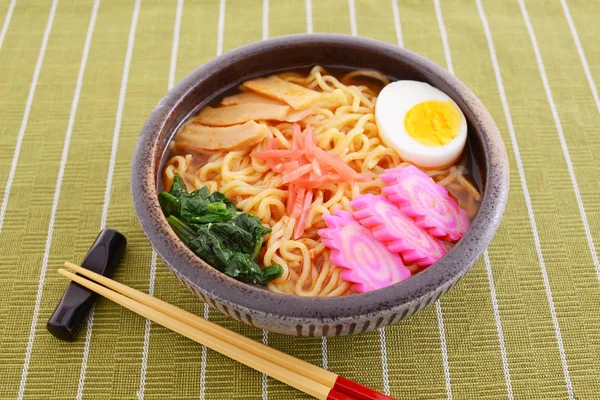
<box><xmin>63</xmin><ymin>262</ymin><xmax>393</xmax><ymax>400</ymax></box>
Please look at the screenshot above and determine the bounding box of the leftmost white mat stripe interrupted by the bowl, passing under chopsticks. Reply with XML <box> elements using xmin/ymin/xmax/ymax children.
<box><xmin>137</xmin><ymin>0</ymin><xmax>183</xmax><ymax>400</ymax></box>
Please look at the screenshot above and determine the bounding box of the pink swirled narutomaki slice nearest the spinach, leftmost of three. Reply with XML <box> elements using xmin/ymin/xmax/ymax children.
<box><xmin>319</xmin><ymin>210</ymin><xmax>410</xmax><ymax>293</ymax></box>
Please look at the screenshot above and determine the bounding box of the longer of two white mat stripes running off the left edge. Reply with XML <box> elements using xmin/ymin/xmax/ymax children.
<box><xmin>0</xmin><ymin>0</ymin><xmax>58</xmax><ymax>232</ymax></box>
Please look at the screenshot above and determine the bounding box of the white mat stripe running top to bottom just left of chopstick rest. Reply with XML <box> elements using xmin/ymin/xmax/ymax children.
<box><xmin>17</xmin><ymin>0</ymin><xmax>100</xmax><ymax>400</ymax></box>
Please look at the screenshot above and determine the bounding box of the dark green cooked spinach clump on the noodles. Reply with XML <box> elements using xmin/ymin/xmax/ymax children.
<box><xmin>159</xmin><ymin>175</ymin><xmax>283</xmax><ymax>285</ymax></box>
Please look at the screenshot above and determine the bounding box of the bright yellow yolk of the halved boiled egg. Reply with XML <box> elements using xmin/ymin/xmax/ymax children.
<box><xmin>404</xmin><ymin>100</ymin><xmax>462</xmax><ymax>146</ymax></box>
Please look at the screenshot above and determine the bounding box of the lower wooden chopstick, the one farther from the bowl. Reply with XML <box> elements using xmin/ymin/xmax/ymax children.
<box><xmin>58</xmin><ymin>268</ymin><xmax>356</xmax><ymax>400</ymax></box>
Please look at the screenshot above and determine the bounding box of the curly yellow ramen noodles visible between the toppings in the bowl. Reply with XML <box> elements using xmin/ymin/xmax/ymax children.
<box><xmin>163</xmin><ymin>66</ymin><xmax>481</xmax><ymax>296</ymax></box>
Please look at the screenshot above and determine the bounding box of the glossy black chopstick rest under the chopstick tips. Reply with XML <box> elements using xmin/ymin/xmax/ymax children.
<box><xmin>46</xmin><ymin>229</ymin><xmax>127</xmax><ymax>341</ymax></box>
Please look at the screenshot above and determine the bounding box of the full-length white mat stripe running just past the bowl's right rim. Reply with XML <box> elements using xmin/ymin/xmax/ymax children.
<box><xmin>475</xmin><ymin>0</ymin><xmax>575</xmax><ymax>400</ymax></box>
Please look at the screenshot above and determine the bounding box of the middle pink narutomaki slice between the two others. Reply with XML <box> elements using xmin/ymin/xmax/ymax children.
<box><xmin>350</xmin><ymin>194</ymin><xmax>446</xmax><ymax>267</ymax></box>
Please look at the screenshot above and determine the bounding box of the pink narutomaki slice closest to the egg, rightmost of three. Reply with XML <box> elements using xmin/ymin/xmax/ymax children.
<box><xmin>380</xmin><ymin>165</ymin><xmax>469</xmax><ymax>242</ymax></box>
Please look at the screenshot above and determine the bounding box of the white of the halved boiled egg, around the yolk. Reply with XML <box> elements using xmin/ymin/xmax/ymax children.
<box><xmin>375</xmin><ymin>80</ymin><xmax>467</xmax><ymax>169</ymax></box>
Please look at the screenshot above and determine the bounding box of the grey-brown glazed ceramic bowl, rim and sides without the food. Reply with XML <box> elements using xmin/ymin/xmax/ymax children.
<box><xmin>131</xmin><ymin>34</ymin><xmax>509</xmax><ymax>336</ymax></box>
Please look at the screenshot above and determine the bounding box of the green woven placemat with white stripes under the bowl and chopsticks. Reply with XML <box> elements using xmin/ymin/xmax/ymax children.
<box><xmin>0</xmin><ymin>0</ymin><xmax>600</xmax><ymax>399</ymax></box>
